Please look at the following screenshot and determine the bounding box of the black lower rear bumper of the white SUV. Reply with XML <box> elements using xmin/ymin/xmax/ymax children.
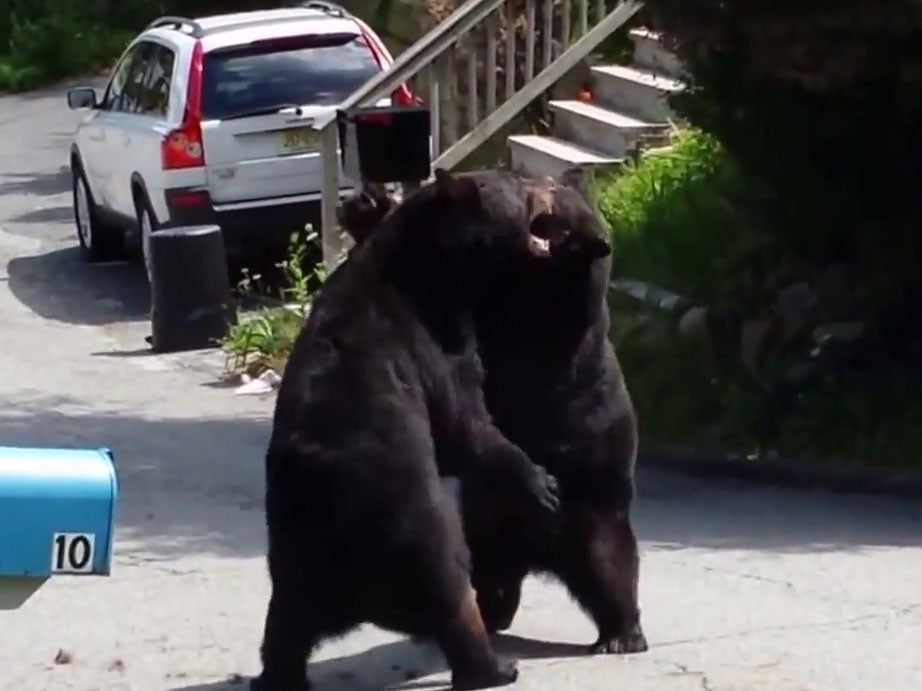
<box><xmin>160</xmin><ymin>187</ymin><xmax>353</xmax><ymax>254</ymax></box>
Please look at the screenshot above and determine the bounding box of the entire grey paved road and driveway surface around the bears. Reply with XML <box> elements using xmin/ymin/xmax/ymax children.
<box><xmin>0</xmin><ymin>85</ymin><xmax>922</xmax><ymax>691</ymax></box>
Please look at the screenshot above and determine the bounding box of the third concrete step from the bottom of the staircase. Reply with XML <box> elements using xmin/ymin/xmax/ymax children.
<box><xmin>591</xmin><ymin>65</ymin><xmax>685</xmax><ymax>123</ymax></box>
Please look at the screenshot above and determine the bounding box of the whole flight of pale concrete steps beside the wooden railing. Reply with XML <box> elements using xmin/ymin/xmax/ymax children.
<box><xmin>508</xmin><ymin>29</ymin><xmax>684</xmax><ymax>176</ymax></box>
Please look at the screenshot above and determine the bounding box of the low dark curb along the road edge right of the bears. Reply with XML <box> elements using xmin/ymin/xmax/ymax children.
<box><xmin>637</xmin><ymin>445</ymin><xmax>922</xmax><ymax>499</ymax></box>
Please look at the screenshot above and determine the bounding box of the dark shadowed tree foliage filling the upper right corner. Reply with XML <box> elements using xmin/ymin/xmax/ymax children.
<box><xmin>644</xmin><ymin>0</ymin><xmax>922</xmax><ymax>354</ymax></box>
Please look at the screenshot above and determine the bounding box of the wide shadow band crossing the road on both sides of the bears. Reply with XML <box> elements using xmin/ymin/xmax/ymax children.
<box><xmin>0</xmin><ymin>394</ymin><xmax>922</xmax><ymax>558</ymax></box>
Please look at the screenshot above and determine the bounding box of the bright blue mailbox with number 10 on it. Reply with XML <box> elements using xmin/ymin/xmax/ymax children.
<box><xmin>0</xmin><ymin>447</ymin><xmax>118</xmax><ymax>609</ymax></box>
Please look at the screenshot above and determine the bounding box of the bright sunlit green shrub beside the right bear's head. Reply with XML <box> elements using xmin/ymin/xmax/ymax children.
<box><xmin>596</xmin><ymin>129</ymin><xmax>764</xmax><ymax>300</ymax></box>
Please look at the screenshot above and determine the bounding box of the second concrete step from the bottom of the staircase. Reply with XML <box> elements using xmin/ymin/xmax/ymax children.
<box><xmin>548</xmin><ymin>101</ymin><xmax>667</xmax><ymax>158</ymax></box>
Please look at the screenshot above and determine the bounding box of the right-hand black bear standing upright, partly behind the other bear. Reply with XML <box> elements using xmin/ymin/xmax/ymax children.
<box><xmin>338</xmin><ymin>169</ymin><xmax>647</xmax><ymax>652</ymax></box>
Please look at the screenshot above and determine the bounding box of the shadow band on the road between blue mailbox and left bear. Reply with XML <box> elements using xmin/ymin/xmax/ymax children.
<box><xmin>0</xmin><ymin>394</ymin><xmax>271</xmax><ymax>562</ymax></box>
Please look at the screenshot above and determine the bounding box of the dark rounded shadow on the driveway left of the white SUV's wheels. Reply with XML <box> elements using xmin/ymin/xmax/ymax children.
<box><xmin>6</xmin><ymin>246</ymin><xmax>150</xmax><ymax>325</ymax></box>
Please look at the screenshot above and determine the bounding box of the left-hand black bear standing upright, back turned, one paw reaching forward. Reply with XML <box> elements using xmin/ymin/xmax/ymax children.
<box><xmin>251</xmin><ymin>171</ymin><xmax>559</xmax><ymax>691</ymax></box>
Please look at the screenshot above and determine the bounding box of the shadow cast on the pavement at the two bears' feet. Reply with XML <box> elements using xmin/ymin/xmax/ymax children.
<box><xmin>168</xmin><ymin>634</ymin><xmax>586</xmax><ymax>691</ymax></box>
